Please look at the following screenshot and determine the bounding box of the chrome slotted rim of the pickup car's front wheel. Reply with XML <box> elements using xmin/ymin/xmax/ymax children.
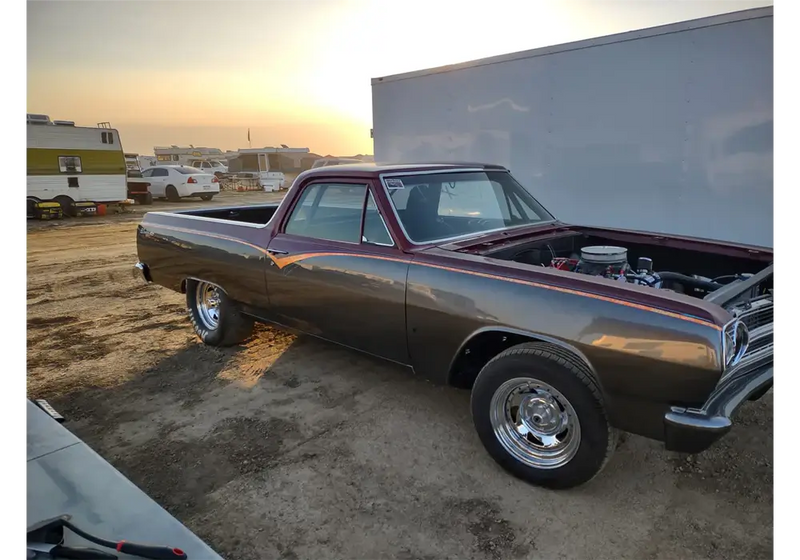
<box><xmin>489</xmin><ymin>377</ymin><xmax>581</xmax><ymax>469</ymax></box>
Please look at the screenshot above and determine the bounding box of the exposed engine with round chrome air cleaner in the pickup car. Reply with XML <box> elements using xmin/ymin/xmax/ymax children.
<box><xmin>550</xmin><ymin>245</ymin><xmax>751</xmax><ymax>297</ymax></box>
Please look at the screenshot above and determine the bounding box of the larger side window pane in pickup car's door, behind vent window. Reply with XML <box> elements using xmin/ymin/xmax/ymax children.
<box><xmin>284</xmin><ymin>184</ymin><xmax>367</xmax><ymax>243</ymax></box>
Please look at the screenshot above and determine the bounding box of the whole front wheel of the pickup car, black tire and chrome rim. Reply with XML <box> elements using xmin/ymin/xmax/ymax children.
<box><xmin>471</xmin><ymin>342</ymin><xmax>617</xmax><ymax>489</ymax></box>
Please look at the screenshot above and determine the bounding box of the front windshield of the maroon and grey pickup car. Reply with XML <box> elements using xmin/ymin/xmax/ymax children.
<box><xmin>384</xmin><ymin>171</ymin><xmax>554</xmax><ymax>243</ymax></box>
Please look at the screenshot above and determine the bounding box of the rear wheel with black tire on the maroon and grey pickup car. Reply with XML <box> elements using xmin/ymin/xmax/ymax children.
<box><xmin>186</xmin><ymin>280</ymin><xmax>254</xmax><ymax>346</ymax></box>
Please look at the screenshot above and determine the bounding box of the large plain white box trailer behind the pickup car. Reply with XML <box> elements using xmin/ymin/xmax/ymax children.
<box><xmin>372</xmin><ymin>7</ymin><xmax>776</xmax><ymax>248</ymax></box>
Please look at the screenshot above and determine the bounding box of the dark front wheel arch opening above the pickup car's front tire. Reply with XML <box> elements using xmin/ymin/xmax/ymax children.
<box><xmin>447</xmin><ymin>326</ymin><xmax>602</xmax><ymax>390</ymax></box>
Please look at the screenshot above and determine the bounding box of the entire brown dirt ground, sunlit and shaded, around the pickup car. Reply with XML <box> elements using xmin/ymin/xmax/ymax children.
<box><xmin>25</xmin><ymin>193</ymin><xmax>776</xmax><ymax>560</ymax></box>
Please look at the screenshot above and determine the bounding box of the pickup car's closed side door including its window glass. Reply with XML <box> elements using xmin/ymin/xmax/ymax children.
<box><xmin>267</xmin><ymin>180</ymin><xmax>410</xmax><ymax>364</ymax></box>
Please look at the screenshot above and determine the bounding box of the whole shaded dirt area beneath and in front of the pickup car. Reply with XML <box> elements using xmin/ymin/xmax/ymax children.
<box><xmin>42</xmin><ymin>327</ymin><xmax>775</xmax><ymax>559</ymax></box>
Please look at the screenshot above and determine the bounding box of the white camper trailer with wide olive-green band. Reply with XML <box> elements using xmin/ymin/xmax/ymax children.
<box><xmin>24</xmin><ymin>114</ymin><xmax>127</xmax><ymax>215</ymax></box>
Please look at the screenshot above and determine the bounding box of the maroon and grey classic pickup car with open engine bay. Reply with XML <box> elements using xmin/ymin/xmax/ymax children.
<box><xmin>134</xmin><ymin>164</ymin><xmax>776</xmax><ymax>488</ymax></box>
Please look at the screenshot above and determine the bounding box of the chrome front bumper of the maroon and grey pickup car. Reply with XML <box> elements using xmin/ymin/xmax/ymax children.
<box><xmin>664</xmin><ymin>342</ymin><xmax>777</xmax><ymax>453</ymax></box>
